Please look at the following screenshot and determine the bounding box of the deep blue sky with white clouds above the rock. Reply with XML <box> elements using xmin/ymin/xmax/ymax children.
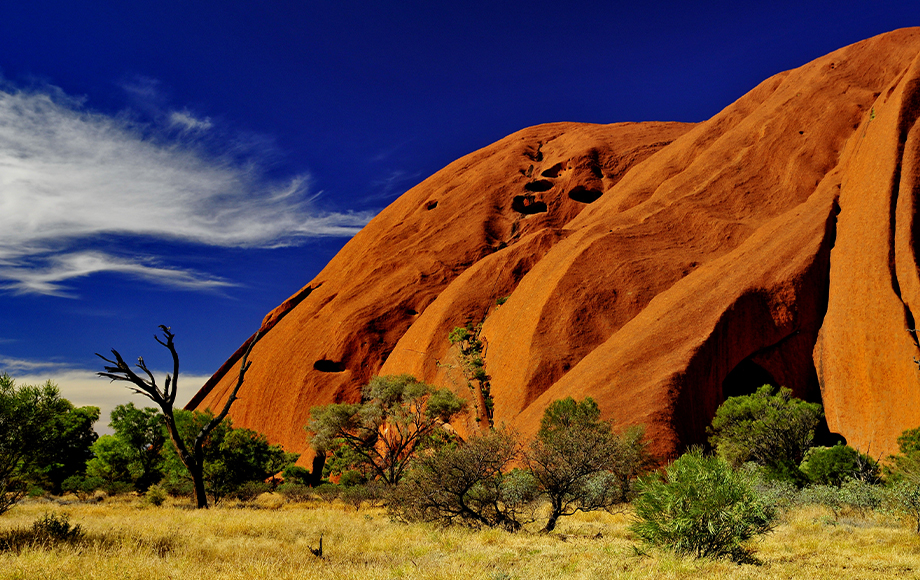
<box><xmin>0</xmin><ymin>0</ymin><xmax>920</xmax><ymax>426</ymax></box>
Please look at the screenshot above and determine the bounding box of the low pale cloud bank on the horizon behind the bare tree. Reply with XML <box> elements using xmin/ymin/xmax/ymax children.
<box><xmin>0</xmin><ymin>356</ymin><xmax>210</xmax><ymax>434</ymax></box>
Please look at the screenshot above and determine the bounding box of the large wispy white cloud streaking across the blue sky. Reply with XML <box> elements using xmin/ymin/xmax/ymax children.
<box><xmin>0</xmin><ymin>79</ymin><xmax>370</xmax><ymax>295</ymax></box>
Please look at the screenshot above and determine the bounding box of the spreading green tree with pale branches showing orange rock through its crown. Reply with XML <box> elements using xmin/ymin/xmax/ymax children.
<box><xmin>306</xmin><ymin>375</ymin><xmax>465</xmax><ymax>485</ymax></box>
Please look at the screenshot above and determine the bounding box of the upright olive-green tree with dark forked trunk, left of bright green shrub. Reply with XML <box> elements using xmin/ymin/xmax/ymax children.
<box><xmin>526</xmin><ymin>397</ymin><xmax>648</xmax><ymax>532</ymax></box>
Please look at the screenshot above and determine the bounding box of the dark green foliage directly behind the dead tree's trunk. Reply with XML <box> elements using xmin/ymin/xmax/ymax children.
<box><xmin>162</xmin><ymin>410</ymin><xmax>298</xmax><ymax>504</ymax></box>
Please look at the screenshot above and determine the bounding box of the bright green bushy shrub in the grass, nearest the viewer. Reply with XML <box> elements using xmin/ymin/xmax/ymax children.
<box><xmin>630</xmin><ymin>450</ymin><xmax>775</xmax><ymax>562</ymax></box>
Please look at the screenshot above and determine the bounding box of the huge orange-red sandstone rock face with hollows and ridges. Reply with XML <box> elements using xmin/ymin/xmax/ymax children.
<box><xmin>189</xmin><ymin>28</ymin><xmax>920</xmax><ymax>457</ymax></box>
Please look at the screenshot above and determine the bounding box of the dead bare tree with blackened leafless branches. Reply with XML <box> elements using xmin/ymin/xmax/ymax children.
<box><xmin>96</xmin><ymin>324</ymin><xmax>259</xmax><ymax>509</ymax></box>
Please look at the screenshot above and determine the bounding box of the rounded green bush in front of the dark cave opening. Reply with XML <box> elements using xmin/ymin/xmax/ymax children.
<box><xmin>708</xmin><ymin>385</ymin><xmax>824</xmax><ymax>483</ymax></box>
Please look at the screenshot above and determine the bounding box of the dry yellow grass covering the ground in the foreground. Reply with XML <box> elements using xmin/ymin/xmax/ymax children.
<box><xmin>0</xmin><ymin>498</ymin><xmax>920</xmax><ymax>580</ymax></box>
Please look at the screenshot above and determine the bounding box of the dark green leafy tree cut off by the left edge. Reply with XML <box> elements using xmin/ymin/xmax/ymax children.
<box><xmin>0</xmin><ymin>373</ymin><xmax>99</xmax><ymax>514</ymax></box>
